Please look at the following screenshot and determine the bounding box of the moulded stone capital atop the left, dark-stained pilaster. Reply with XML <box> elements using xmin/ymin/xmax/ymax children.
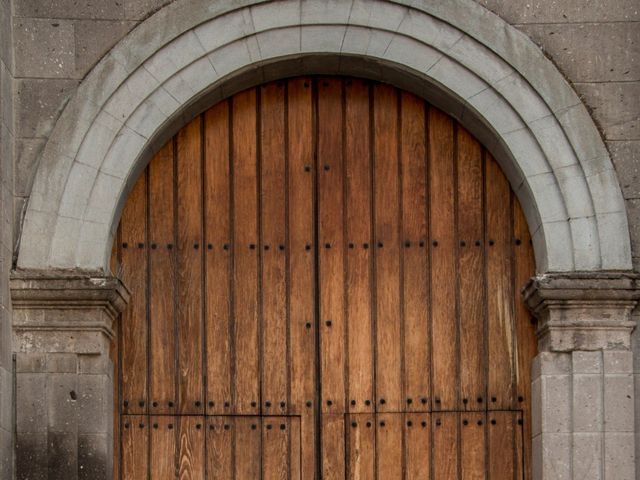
<box><xmin>10</xmin><ymin>270</ymin><xmax>130</xmax><ymax>353</ymax></box>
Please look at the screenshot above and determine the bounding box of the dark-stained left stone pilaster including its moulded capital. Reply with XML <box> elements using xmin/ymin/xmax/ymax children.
<box><xmin>11</xmin><ymin>271</ymin><xmax>129</xmax><ymax>480</ymax></box>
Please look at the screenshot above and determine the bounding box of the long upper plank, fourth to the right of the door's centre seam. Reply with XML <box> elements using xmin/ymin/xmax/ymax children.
<box><xmin>400</xmin><ymin>92</ymin><xmax>431</xmax><ymax>411</ymax></box>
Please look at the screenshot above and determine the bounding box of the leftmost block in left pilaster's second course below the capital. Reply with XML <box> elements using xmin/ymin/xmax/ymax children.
<box><xmin>16</xmin><ymin>373</ymin><xmax>48</xmax><ymax>435</ymax></box>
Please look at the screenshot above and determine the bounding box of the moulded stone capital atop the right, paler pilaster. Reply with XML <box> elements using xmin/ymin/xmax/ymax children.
<box><xmin>522</xmin><ymin>272</ymin><xmax>640</xmax><ymax>352</ymax></box>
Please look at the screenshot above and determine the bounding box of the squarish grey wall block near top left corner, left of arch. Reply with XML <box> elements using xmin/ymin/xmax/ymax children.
<box><xmin>13</xmin><ymin>18</ymin><xmax>75</xmax><ymax>78</ymax></box>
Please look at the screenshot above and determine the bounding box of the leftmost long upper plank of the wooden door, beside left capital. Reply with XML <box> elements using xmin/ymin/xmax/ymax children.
<box><xmin>120</xmin><ymin>174</ymin><xmax>148</xmax><ymax>413</ymax></box>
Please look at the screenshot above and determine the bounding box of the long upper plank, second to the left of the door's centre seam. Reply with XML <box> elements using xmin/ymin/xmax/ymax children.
<box><xmin>259</xmin><ymin>82</ymin><xmax>289</xmax><ymax>414</ymax></box>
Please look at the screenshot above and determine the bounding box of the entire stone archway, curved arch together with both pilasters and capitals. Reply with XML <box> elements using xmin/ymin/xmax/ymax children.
<box><xmin>11</xmin><ymin>0</ymin><xmax>638</xmax><ymax>479</ymax></box>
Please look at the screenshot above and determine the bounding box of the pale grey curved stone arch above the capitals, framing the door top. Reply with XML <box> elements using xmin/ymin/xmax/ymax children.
<box><xmin>18</xmin><ymin>0</ymin><xmax>631</xmax><ymax>273</ymax></box>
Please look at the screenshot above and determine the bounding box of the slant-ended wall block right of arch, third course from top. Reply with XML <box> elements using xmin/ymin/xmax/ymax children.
<box><xmin>574</xmin><ymin>82</ymin><xmax>640</xmax><ymax>140</ymax></box>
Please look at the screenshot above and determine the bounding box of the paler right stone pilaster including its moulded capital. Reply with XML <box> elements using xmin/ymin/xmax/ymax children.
<box><xmin>523</xmin><ymin>272</ymin><xmax>640</xmax><ymax>480</ymax></box>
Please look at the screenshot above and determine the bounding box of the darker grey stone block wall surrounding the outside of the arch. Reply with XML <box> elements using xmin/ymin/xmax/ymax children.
<box><xmin>0</xmin><ymin>0</ymin><xmax>640</xmax><ymax>478</ymax></box>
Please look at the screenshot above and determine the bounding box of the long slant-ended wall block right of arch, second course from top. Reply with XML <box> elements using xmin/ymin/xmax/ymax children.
<box><xmin>519</xmin><ymin>22</ymin><xmax>640</xmax><ymax>82</ymax></box>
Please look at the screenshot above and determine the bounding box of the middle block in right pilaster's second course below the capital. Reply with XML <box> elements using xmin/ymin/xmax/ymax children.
<box><xmin>572</xmin><ymin>374</ymin><xmax>603</xmax><ymax>432</ymax></box>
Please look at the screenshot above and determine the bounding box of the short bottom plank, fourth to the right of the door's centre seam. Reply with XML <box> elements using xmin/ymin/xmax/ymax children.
<box><xmin>404</xmin><ymin>413</ymin><xmax>431</xmax><ymax>480</ymax></box>
